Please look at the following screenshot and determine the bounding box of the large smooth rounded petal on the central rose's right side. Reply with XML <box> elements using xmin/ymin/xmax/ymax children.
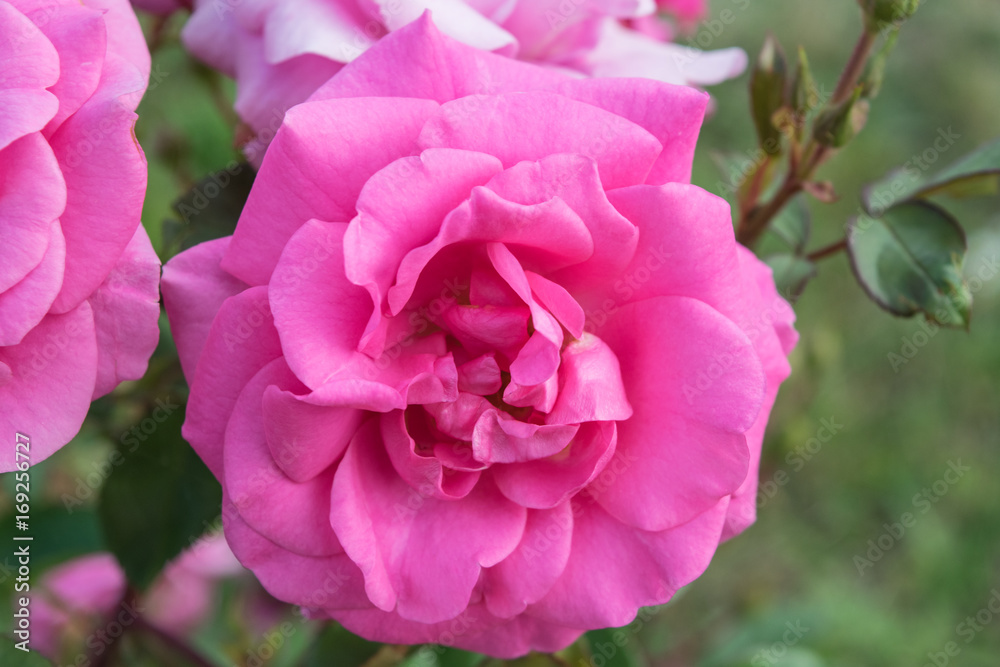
<box><xmin>595</xmin><ymin>297</ymin><xmax>764</xmax><ymax>531</ymax></box>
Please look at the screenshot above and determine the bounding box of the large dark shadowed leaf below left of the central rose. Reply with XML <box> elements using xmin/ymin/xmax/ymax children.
<box><xmin>98</xmin><ymin>399</ymin><xmax>222</xmax><ymax>589</ymax></box>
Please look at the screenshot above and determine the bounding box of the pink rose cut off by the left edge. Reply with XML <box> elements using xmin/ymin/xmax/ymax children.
<box><xmin>0</xmin><ymin>0</ymin><xmax>160</xmax><ymax>472</ymax></box>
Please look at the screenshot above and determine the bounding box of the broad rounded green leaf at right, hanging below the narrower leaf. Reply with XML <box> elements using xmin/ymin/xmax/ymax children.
<box><xmin>847</xmin><ymin>202</ymin><xmax>972</xmax><ymax>328</ymax></box>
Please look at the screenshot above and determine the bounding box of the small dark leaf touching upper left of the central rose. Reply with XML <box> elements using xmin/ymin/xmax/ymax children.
<box><xmin>163</xmin><ymin>161</ymin><xmax>256</xmax><ymax>260</ymax></box>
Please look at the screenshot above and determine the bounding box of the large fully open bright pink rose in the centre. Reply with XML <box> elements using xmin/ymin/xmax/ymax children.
<box><xmin>163</xmin><ymin>19</ymin><xmax>796</xmax><ymax>657</ymax></box>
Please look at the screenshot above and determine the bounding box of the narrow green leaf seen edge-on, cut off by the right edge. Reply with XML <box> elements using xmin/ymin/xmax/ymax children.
<box><xmin>863</xmin><ymin>138</ymin><xmax>1000</xmax><ymax>215</ymax></box>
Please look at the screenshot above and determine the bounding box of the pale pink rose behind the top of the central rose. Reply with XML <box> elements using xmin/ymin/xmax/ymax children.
<box><xmin>183</xmin><ymin>0</ymin><xmax>746</xmax><ymax>164</ymax></box>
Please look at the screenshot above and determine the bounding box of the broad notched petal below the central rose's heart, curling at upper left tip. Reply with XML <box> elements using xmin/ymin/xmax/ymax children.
<box><xmin>330</xmin><ymin>419</ymin><xmax>526</xmax><ymax>623</ymax></box>
